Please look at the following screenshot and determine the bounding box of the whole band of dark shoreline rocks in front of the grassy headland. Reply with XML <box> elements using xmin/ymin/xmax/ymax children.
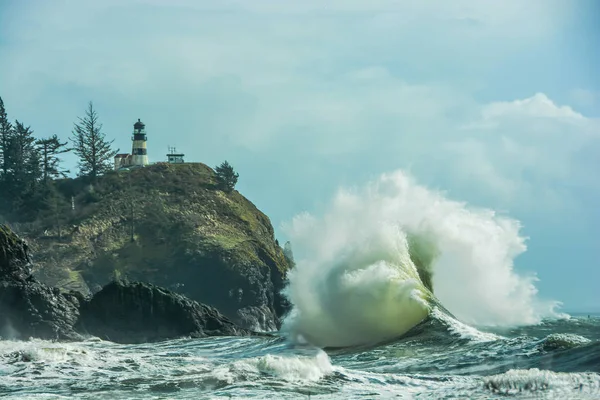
<box><xmin>0</xmin><ymin>225</ymin><xmax>251</xmax><ymax>343</ymax></box>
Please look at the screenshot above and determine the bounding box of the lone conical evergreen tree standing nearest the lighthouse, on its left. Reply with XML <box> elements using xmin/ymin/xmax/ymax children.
<box><xmin>71</xmin><ymin>102</ymin><xmax>119</xmax><ymax>181</ymax></box>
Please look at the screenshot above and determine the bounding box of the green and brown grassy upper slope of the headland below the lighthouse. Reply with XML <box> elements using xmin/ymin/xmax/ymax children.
<box><xmin>17</xmin><ymin>163</ymin><xmax>287</xmax><ymax>281</ymax></box>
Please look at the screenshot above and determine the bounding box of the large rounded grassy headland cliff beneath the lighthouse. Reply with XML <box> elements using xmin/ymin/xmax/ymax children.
<box><xmin>27</xmin><ymin>164</ymin><xmax>289</xmax><ymax>330</ymax></box>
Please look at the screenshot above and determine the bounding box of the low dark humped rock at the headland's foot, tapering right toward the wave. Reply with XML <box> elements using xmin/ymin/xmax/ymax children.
<box><xmin>78</xmin><ymin>282</ymin><xmax>251</xmax><ymax>343</ymax></box>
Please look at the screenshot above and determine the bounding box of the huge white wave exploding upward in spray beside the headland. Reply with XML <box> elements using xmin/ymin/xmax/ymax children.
<box><xmin>283</xmin><ymin>171</ymin><xmax>556</xmax><ymax>346</ymax></box>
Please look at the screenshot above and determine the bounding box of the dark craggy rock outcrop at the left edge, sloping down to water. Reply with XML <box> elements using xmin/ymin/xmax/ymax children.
<box><xmin>0</xmin><ymin>225</ymin><xmax>82</xmax><ymax>340</ymax></box>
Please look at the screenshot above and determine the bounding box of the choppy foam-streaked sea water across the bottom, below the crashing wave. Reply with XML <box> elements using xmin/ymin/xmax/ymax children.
<box><xmin>0</xmin><ymin>313</ymin><xmax>600</xmax><ymax>399</ymax></box>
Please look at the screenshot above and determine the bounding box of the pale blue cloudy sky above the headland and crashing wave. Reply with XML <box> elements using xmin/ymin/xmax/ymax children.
<box><xmin>0</xmin><ymin>0</ymin><xmax>600</xmax><ymax>311</ymax></box>
